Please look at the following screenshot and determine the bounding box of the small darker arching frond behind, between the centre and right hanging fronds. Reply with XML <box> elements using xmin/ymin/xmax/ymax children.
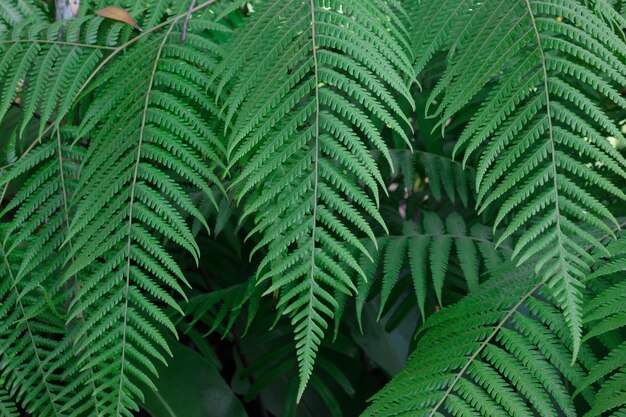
<box><xmin>356</xmin><ymin>212</ymin><xmax>504</xmax><ymax>322</ymax></box>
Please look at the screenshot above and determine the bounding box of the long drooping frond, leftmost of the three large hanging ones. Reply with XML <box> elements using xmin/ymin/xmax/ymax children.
<box><xmin>29</xmin><ymin>13</ymin><xmax>224</xmax><ymax>416</ymax></box>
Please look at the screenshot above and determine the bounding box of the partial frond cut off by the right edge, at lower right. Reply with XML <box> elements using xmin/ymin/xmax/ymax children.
<box><xmin>578</xmin><ymin>234</ymin><xmax>626</xmax><ymax>417</ymax></box>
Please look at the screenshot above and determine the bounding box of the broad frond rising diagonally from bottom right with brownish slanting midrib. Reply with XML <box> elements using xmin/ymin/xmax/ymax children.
<box><xmin>364</xmin><ymin>268</ymin><xmax>595</xmax><ymax>417</ymax></box>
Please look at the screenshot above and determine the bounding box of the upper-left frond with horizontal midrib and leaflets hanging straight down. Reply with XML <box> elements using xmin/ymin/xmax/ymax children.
<box><xmin>0</xmin><ymin>17</ymin><xmax>128</xmax><ymax>136</ymax></box>
